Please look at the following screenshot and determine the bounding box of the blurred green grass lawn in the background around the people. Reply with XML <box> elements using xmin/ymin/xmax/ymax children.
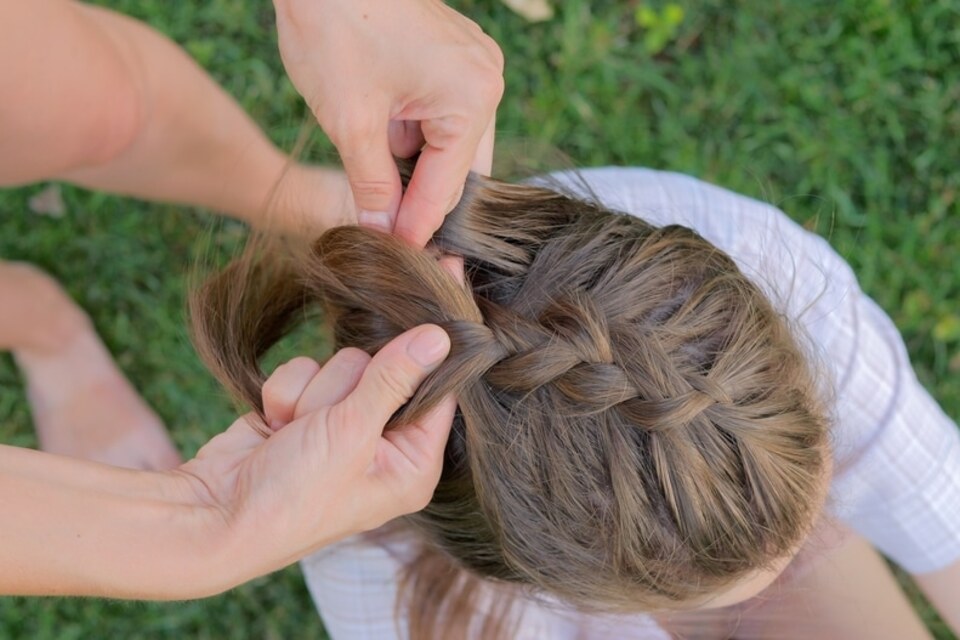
<box><xmin>0</xmin><ymin>0</ymin><xmax>960</xmax><ymax>638</ymax></box>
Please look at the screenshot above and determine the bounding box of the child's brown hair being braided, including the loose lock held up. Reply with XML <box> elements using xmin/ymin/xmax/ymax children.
<box><xmin>198</xmin><ymin>170</ymin><xmax>828</xmax><ymax>624</ymax></box>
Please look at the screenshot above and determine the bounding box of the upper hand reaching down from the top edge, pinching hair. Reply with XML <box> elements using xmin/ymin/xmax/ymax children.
<box><xmin>274</xmin><ymin>0</ymin><xmax>503</xmax><ymax>246</ymax></box>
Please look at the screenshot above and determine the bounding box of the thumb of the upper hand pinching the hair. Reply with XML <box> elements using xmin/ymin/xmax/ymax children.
<box><xmin>334</xmin><ymin>116</ymin><xmax>401</xmax><ymax>233</ymax></box>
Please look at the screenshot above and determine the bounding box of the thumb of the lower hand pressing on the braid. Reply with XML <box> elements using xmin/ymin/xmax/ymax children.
<box><xmin>330</xmin><ymin>324</ymin><xmax>450</xmax><ymax>439</ymax></box>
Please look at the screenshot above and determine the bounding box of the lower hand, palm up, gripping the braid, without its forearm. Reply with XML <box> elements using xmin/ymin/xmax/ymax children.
<box><xmin>177</xmin><ymin>325</ymin><xmax>456</xmax><ymax>586</ymax></box>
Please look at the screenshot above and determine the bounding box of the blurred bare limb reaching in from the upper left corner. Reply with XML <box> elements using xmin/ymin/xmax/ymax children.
<box><xmin>0</xmin><ymin>0</ymin><xmax>352</xmax><ymax>228</ymax></box>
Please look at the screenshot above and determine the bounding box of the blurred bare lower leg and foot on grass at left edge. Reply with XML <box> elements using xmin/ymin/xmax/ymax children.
<box><xmin>0</xmin><ymin>262</ymin><xmax>180</xmax><ymax>469</ymax></box>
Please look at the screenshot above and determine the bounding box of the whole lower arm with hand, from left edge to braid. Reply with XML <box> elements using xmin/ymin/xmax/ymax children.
<box><xmin>0</xmin><ymin>326</ymin><xmax>454</xmax><ymax>599</ymax></box>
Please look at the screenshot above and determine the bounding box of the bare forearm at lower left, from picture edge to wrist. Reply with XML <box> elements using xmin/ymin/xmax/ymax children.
<box><xmin>0</xmin><ymin>446</ymin><xmax>241</xmax><ymax>600</ymax></box>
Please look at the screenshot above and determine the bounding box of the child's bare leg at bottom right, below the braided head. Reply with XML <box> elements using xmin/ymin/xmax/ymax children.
<box><xmin>662</xmin><ymin>525</ymin><xmax>931</xmax><ymax>640</ymax></box>
